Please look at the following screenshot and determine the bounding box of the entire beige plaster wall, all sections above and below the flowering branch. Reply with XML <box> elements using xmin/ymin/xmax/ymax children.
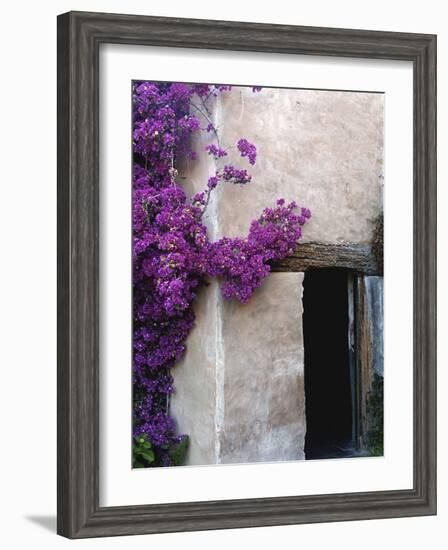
<box><xmin>171</xmin><ymin>88</ymin><xmax>383</xmax><ymax>464</ymax></box>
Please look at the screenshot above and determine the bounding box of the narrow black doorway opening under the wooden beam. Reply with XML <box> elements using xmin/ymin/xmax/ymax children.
<box><xmin>303</xmin><ymin>269</ymin><xmax>354</xmax><ymax>459</ymax></box>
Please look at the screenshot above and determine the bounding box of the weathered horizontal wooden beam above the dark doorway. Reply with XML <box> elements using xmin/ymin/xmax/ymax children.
<box><xmin>272</xmin><ymin>242</ymin><xmax>383</xmax><ymax>275</ymax></box>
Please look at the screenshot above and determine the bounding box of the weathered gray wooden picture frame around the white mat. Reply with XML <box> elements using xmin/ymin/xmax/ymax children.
<box><xmin>57</xmin><ymin>12</ymin><xmax>436</xmax><ymax>538</ymax></box>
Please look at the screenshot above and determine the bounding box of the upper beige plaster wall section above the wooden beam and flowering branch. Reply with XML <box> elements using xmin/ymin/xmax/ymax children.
<box><xmin>217</xmin><ymin>88</ymin><xmax>384</xmax><ymax>243</ymax></box>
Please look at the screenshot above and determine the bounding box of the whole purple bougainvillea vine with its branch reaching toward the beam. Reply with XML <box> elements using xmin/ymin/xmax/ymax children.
<box><xmin>133</xmin><ymin>82</ymin><xmax>311</xmax><ymax>467</ymax></box>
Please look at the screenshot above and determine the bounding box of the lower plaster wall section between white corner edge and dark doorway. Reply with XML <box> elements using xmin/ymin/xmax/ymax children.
<box><xmin>220</xmin><ymin>273</ymin><xmax>305</xmax><ymax>463</ymax></box>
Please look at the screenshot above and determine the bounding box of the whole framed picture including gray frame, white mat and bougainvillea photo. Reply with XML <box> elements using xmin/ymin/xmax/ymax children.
<box><xmin>58</xmin><ymin>12</ymin><xmax>436</xmax><ymax>538</ymax></box>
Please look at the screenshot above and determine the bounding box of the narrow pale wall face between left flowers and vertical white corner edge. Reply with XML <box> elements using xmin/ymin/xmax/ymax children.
<box><xmin>170</xmin><ymin>122</ymin><xmax>222</xmax><ymax>464</ymax></box>
